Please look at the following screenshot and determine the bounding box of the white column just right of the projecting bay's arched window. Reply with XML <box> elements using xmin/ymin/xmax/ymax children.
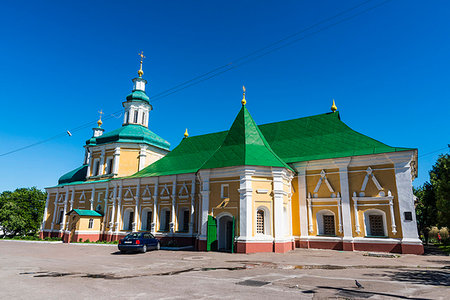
<box><xmin>272</xmin><ymin>168</ymin><xmax>286</xmax><ymax>242</ymax></box>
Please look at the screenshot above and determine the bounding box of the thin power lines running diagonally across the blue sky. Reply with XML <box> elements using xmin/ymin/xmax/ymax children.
<box><xmin>0</xmin><ymin>0</ymin><xmax>392</xmax><ymax>157</ymax></box>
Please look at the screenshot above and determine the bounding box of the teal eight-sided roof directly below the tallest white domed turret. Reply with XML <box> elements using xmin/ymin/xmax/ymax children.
<box><xmin>86</xmin><ymin>124</ymin><xmax>170</xmax><ymax>150</ymax></box>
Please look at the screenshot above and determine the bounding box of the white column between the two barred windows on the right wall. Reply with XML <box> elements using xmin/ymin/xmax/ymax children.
<box><xmin>335</xmin><ymin>158</ymin><xmax>353</xmax><ymax>242</ymax></box>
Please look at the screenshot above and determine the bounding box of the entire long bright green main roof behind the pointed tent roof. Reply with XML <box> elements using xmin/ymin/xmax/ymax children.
<box><xmin>131</xmin><ymin>108</ymin><xmax>413</xmax><ymax>177</ymax></box>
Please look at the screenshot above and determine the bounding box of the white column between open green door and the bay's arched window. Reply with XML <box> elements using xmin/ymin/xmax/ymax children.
<box><xmin>237</xmin><ymin>169</ymin><xmax>255</xmax><ymax>241</ymax></box>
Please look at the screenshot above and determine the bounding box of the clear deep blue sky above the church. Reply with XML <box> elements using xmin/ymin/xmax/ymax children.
<box><xmin>0</xmin><ymin>0</ymin><xmax>450</xmax><ymax>191</ymax></box>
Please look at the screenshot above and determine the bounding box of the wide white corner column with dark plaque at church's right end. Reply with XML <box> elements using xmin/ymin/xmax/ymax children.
<box><xmin>394</xmin><ymin>158</ymin><xmax>421</xmax><ymax>244</ymax></box>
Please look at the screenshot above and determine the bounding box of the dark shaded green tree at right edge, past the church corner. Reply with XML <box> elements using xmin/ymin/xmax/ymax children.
<box><xmin>430</xmin><ymin>154</ymin><xmax>450</xmax><ymax>227</ymax></box>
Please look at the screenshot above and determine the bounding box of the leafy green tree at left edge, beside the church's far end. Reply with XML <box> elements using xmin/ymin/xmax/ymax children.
<box><xmin>0</xmin><ymin>187</ymin><xmax>47</xmax><ymax>235</ymax></box>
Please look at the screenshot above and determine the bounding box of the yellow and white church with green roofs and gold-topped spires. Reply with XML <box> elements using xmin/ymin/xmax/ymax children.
<box><xmin>40</xmin><ymin>56</ymin><xmax>423</xmax><ymax>254</ymax></box>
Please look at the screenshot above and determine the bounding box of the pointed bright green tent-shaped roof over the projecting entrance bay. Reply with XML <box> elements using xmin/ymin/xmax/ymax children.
<box><xmin>201</xmin><ymin>105</ymin><xmax>290</xmax><ymax>169</ymax></box>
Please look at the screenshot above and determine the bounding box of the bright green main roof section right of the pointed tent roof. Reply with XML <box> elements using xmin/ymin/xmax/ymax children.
<box><xmin>259</xmin><ymin>112</ymin><xmax>412</xmax><ymax>163</ymax></box>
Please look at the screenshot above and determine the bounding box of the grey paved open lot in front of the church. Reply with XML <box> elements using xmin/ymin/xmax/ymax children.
<box><xmin>0</xmin><ymin>241</ymin><xmax>450</xmax><ymax>300</ymax></box>
